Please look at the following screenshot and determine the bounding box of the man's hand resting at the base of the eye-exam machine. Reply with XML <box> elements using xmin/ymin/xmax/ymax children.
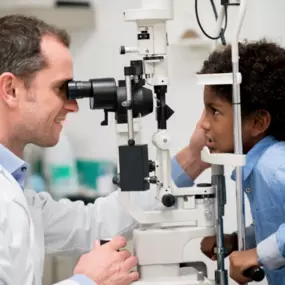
<box><xmin>73</xmin><ymin>234</ymin><xmax>139</xmax><ymax>285</ymax></box>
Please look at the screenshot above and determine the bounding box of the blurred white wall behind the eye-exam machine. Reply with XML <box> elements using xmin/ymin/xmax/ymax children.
<box><xmin>62</xmin><ymin>0</ymin><xmax>285</xmax><ymax>284</ymax></box>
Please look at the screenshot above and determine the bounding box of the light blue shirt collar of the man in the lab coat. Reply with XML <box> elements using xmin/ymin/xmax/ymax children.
<box><xmin>0</xmin><ymin>144</ymin><xmax>28</xmax><ymax>189</ymax></box>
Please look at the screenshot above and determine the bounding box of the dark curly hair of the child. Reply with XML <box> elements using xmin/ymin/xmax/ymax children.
<box><xmin>199</xmin><ymin>40</ymin><xmax>285</xmax><ymax>141</ymax></box>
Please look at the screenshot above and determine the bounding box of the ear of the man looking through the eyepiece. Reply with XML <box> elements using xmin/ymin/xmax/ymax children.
<box><xmin>0</xmin><ymin>72</ymin><xmax>20</xmax><ymax>108</ymax></box>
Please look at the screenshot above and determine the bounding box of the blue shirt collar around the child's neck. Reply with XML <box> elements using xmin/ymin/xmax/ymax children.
<box><xmin>232</xmin><ymin>136</ymin><xmax>278</xmax><ymax>180</ymax></box>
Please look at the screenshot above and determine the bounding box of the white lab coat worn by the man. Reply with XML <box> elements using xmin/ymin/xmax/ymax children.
<box><xmin>0</xmin><ymin>165</ymin><xmax>158</xmax><ymax>285</ymax></box>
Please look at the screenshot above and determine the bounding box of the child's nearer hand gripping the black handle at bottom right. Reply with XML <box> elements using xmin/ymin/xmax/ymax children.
<box><xmin>227</xmin><ymin>248</ymin><xmax>259</xmax><ymax>285</ymax></box>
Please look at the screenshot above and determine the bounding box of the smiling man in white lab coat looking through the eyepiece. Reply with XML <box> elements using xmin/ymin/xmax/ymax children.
<box><xmin>0</xmin><ymin>12</ymin><xmax>205</xmax><ymax>285</ymax></box>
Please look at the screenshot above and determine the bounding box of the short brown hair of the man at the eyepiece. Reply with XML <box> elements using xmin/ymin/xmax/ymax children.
<box><xmin>0</xmin><ymin>14</ymin><xmax>70</xmax><ymax>86</ymax></box>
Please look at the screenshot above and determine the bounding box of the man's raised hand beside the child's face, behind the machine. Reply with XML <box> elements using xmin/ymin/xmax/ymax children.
<box><xmin>176</xmin><ymin>111</ymin><xmax>210</xmax><ymax>180</ymax></box>
